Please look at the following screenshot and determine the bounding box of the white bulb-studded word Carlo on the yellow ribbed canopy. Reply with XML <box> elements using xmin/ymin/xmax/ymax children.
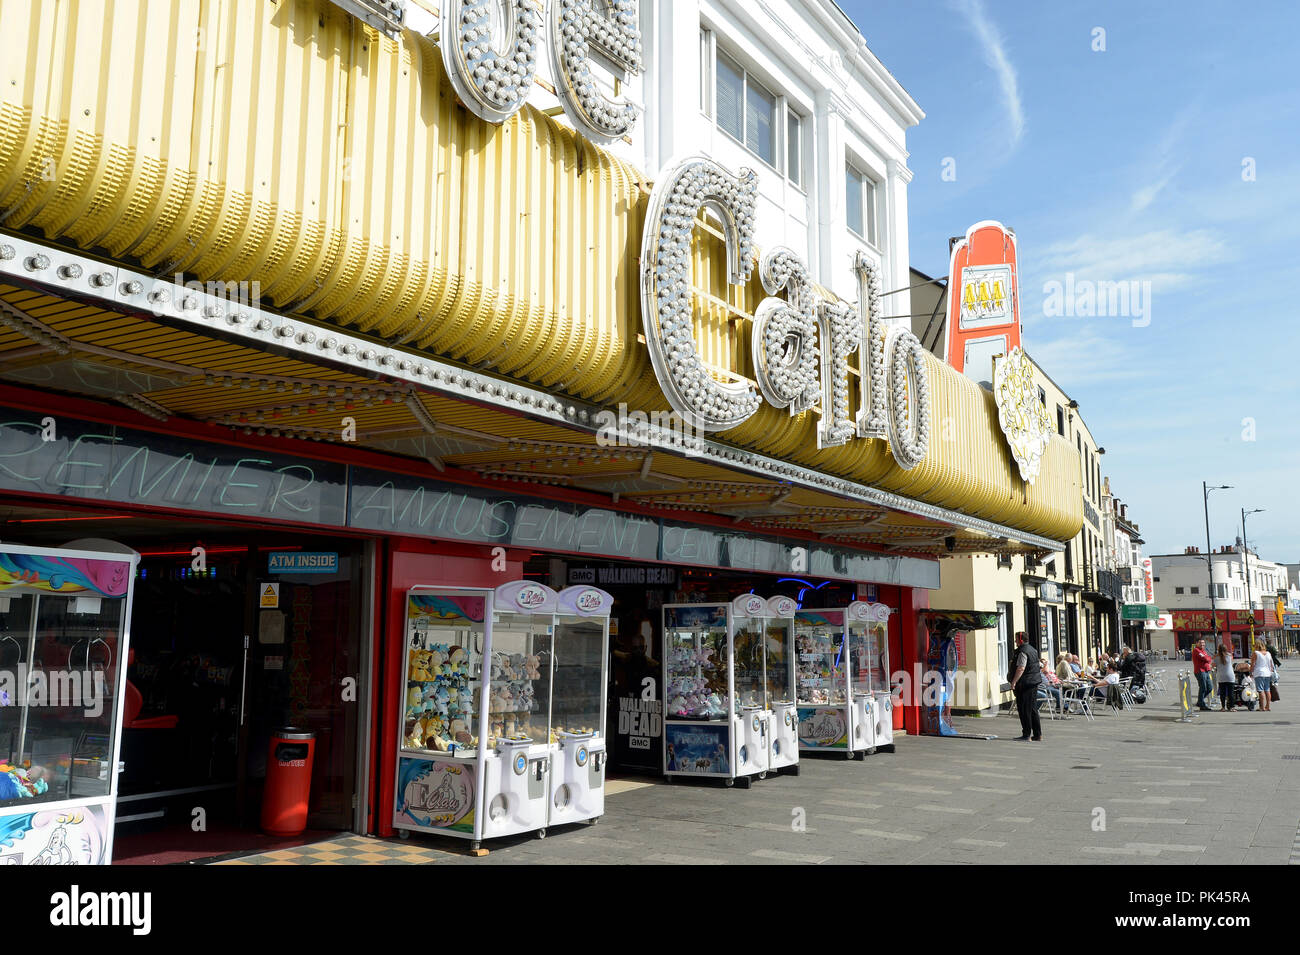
<box><xmin>641</xmin><ymin>156</ymin><xmax>930</xmax><ymax>470</ymax></box>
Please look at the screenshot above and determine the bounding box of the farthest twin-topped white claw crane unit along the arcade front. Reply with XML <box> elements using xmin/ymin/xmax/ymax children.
<box><xmin>794</xmin><ymin>600</ymin><xmax>893</xmax><ymax>759</ymax></box>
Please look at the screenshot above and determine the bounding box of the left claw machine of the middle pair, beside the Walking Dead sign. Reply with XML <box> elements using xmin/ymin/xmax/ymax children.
<box><xmin>663</xmin><ymin>594</ymin><xmax>768</xmax><ymax>786</ymax></box>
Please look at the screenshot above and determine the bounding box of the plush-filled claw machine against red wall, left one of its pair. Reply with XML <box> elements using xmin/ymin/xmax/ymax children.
<box><xmin>393</xmin><ymin>581</ymin><xmax>558</xmax><ymax>850</ymax></box>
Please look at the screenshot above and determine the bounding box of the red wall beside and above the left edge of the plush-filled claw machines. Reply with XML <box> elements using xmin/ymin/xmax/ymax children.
<box><xmin>369</xmin><ymin>539</ymin><xmax>528</xmax><ymax>835</ymax></box>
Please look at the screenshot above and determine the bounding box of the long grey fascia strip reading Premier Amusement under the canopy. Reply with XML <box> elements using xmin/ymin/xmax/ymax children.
<box><xmin>0</xmin><ymin>409</ymin><xmax>939</xmax><ymax>589</ymax></box>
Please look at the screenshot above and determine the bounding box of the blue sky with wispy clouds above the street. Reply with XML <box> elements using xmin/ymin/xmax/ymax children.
<box><xmin>841</xmin><ymin>0</ymin><xmax>1300</xmax><ymax>561</ymax></box>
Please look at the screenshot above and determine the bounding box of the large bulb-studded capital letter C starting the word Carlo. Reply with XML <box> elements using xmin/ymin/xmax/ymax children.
<box><xmin>641</xmin><ymin>156</ymin><xmax>758</xmax><ymax>431</ymax></box>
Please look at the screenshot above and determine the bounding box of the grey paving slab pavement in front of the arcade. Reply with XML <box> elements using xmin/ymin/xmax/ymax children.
<box><xmin>226</xmin><ymin>667</ymin><xmax>1300</xmax><ymax>865</ymax></box>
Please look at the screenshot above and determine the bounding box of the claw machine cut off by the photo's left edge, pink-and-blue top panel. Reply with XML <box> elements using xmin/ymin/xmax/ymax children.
<box><xmin>0</xmin><ymin>539</ymin><xmax>140</xmax><ymax>865</ymax></box>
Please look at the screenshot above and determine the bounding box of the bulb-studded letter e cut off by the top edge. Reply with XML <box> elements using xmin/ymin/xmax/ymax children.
<box><xmin>549</xmin><ymin>0</ymin><xmax>641</xmax><ymax>143</ymax></box>
